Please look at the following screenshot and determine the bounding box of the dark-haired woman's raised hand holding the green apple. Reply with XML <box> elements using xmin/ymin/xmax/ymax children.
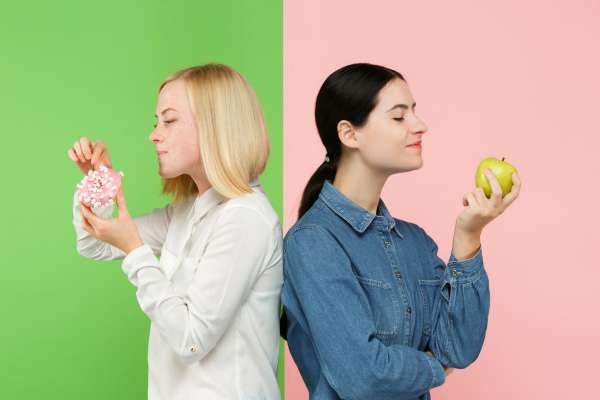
<box><xmin>456</xmin><ymin>169</ymin><xmax>521</xmax><ymax>234</ymax></box>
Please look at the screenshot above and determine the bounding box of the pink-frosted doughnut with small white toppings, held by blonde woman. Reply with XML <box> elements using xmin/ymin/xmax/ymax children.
<box><xmin>77</xmin><ymin>165</ymin><xmax>124</xmax><ymax>207</ymax></box>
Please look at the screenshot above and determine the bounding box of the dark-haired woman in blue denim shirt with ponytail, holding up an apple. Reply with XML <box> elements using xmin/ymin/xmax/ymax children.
<box><xmin>282</xmin><ymin>64</ymin><xmax>521</xmax><ymax>400</ymax></box>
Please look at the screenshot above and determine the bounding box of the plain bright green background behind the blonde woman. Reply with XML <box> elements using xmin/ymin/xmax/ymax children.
<box><xmin>0</xmin><ymin>0</ymin><xmax>283</xmax><ymax>399</ymax></box>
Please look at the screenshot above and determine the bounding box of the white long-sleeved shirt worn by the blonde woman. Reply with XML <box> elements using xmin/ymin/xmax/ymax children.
<box><xmin>73</xmin><ymin>180</ymin><xmax>283</xmax><ymax>400</ymax></box>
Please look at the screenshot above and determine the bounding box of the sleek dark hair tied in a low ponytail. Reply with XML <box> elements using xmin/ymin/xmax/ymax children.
<box><xmin>298</xmin><ymin>63</ymin><xmax>405</xmax><ymax>218</ymax></box>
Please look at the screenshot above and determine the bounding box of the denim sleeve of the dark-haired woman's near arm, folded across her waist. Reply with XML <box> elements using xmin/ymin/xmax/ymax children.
<box><xmin>284</xmin><ymin>225</ymin><xmax>445</xmax><ymax>400</ymax></box>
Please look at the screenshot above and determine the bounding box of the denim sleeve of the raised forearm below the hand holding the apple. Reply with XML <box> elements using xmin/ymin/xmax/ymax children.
<box><xmin>422</xmin><ymin>230</ymin><xmax>490</xmax><ymax>368</ymax></box>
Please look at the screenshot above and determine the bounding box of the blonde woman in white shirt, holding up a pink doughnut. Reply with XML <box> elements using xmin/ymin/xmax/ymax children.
<box><xmin>68</xmin><ymin>64</ymin><xmax>282</xmax><ymax>400</ymax></box>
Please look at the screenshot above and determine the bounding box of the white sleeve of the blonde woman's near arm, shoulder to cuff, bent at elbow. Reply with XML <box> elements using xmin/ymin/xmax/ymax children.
<box><xmin>122</xmin><ymin>206</ymin><xmax>278</xmax><ymax>363</ymax></box>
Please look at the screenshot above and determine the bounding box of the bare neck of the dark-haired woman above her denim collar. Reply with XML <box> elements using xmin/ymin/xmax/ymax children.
<box><xmin>333</xmin><ymin>153</ymin><xmax>388</xmax><ymax>215</ymax></box>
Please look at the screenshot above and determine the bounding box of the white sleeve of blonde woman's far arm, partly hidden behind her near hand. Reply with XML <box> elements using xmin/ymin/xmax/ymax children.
<box><xmin>73</xmin><ymin>192</ymin><xmax>173</xmax><ymax>260</ymax></box>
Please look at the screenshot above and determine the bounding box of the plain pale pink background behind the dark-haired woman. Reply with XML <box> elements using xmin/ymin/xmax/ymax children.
<box><xmin>284</xmin><ymin>0</ymin><xmax>600</xmax><ymax>400</ymax></box>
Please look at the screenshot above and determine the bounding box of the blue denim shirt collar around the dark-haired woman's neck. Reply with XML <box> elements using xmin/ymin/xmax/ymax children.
<box><xmin>319</xmin><ymin>180</ymin><xmax>404</xmax><ymax>238</ymax></box>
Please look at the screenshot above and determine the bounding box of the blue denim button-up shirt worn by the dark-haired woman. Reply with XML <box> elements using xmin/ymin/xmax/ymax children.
<box><xmin>282</xmin><ymin>181</ymin><xmax>490</xmax><ymax>400</ymax></box>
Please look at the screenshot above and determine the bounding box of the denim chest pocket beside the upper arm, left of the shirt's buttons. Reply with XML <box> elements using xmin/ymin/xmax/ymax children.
<box><xmin>355</xmin><ymin>275</ymin><xmax>402</xmax><ymax>345</ymax></box>
